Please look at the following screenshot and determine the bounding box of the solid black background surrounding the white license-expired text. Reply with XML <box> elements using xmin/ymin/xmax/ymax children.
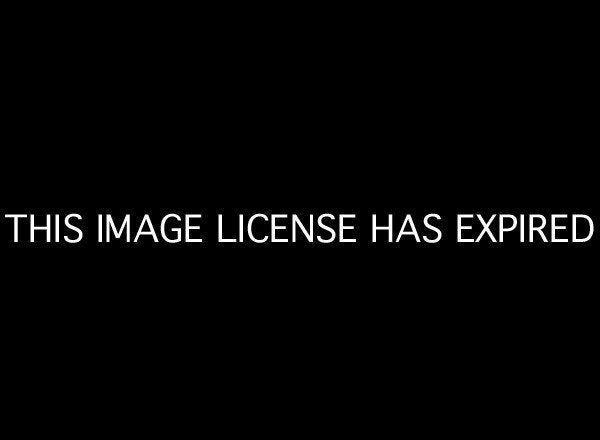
<box><xmin>1</xmin><ymin>5</ymin><xmax>598</xmax><ymax>433</ymax></box>
